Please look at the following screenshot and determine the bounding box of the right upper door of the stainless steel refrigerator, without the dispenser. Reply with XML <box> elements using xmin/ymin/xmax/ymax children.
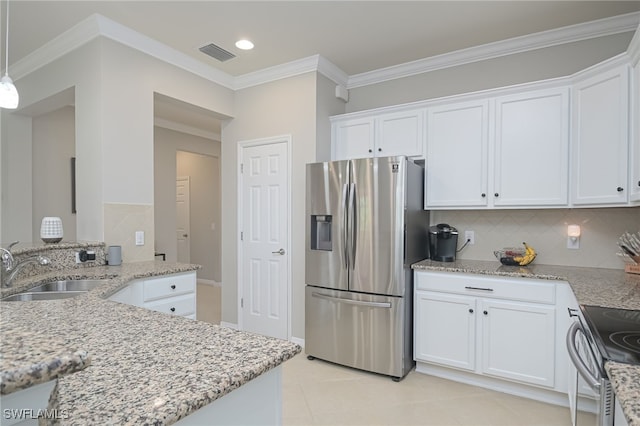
<box><xmin>347</xmin><ymin>157</ymin><xmax>407</xmax><ymax>296</ymax></box>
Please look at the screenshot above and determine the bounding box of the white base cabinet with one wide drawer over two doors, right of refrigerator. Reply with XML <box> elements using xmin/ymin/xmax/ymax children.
<box><xmin>414</xmin><ymin>271</ymin><xmax>556</xmax><ymax>389</ymax></box>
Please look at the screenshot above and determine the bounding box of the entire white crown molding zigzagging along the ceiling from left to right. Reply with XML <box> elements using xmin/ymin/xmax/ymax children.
<box><xmin>11</xmin><ymin>12</ymin><xmax>640</xmax><ymax>90</ymax></box>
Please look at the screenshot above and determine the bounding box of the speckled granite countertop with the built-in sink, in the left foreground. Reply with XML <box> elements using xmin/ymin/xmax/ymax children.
<box><xmin>0</xmin><ymin>262</ymin><xmax>301</xmax><ymax>425</ymax></box>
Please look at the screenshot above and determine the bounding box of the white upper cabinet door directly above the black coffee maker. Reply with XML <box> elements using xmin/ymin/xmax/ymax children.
<box><xmin>425</xmin><ymin>100</ymin><xmax>488</xmax><ymax>208</ymax></box>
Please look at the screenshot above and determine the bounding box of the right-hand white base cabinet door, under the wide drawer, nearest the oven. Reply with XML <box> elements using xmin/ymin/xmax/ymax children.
<box><xmin>478</xmin><ymin>299</ymin><xmax>555</xmax><ymax>388</ymax></box>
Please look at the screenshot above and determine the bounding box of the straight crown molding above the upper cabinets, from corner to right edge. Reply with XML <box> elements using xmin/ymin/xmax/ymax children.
<box><xmin>347</xmin><ymin>12</ymin><xmax>640</xmax><ymax>89</ymax></box>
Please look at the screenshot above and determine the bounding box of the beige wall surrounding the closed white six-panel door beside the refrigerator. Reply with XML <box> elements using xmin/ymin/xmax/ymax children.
<box><xmin>222</xmin><ymin>73</ymin><xmax>316</xmax><ymax>337</ymax></box>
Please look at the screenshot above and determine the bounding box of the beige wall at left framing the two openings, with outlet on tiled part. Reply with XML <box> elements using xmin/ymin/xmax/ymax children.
<box><xmin>2</xmin><ymin>38</ymin><xmax>234</xmax><ymax>261</ymax></box>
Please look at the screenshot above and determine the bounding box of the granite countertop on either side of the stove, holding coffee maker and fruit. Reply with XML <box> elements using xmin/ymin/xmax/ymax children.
<box><xmin>412</xmin><ymin>259</ymin><xmax>640</xmax><ymax>426</ymax></box>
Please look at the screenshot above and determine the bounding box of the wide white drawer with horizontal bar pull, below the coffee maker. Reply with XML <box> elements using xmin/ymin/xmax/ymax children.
<box><xmin>415</xmin><ymin>272</ymin><xmax>556</xmax><ymax>304</ymax></box>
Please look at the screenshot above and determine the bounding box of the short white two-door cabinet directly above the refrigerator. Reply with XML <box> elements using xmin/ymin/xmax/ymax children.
<box><xmin>331</xmin><ymin>108</ymin><xmax>424</xmax><ymax>160</ymax></box>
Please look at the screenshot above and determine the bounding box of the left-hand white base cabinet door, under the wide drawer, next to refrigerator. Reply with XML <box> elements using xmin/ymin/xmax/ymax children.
<box><xmin>414</xmin><ymin>291</ymin><xmax>476</xmax><ymax>371</ymax></box>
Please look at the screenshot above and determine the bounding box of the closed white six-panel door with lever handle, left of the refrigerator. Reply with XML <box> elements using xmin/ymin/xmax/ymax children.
<box><xmin>238</xmin><ymin>139</ymin><xmax>290</xmax><ymax>339</ymax></box>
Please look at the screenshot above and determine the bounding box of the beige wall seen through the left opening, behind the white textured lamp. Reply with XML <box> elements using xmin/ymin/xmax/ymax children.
<box><xmin>32</xmin><ymin>106</ymin><xmax>76</xmax><ymax>242</ymax></box>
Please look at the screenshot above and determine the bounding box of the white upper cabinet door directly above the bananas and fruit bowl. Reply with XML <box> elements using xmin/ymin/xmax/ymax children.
<box><xmin>490</xmin><ymin>88</ymin><xmax>569</xmax><ymax>206</ymax></box>
